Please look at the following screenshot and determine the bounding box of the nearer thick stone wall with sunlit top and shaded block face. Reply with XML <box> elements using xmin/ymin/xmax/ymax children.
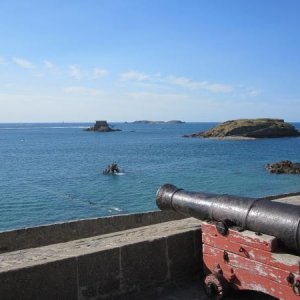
<box><xmin>0</xmin><ymin>218</ymin><xmax>201</xmax><ymax>300</ymax></box>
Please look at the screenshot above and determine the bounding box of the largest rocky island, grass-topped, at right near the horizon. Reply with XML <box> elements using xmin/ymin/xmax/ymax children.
<box><xmin>184</xmin><ymin>118</ymin><xmax>300</xmax><ymax>139</ymax></box>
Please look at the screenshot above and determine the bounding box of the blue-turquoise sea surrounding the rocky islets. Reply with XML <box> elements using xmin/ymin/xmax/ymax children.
<box><xmin>0</xmin><ymin>123</ymin><xmax>300</xmax><ymax>230</ymax></box>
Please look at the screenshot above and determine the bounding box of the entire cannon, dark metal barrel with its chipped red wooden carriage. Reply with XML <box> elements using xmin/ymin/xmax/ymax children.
<box><xmin>156</xmin><ymin>184</ymin><xmax>300</xmax><ymax>300</ymax></box>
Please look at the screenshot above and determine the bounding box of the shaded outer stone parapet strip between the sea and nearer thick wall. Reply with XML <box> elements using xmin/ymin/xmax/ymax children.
<box><xmin>0</xmin><ymin>211</ymin><xmax>185</xmax><ymax>253</ymax></box>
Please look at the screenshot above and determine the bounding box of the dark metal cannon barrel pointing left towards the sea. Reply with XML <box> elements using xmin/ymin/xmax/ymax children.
<box><xmin>156</xmin><ymin>184</ymin><xmax>300</xmax><ymax>254</ymax></box>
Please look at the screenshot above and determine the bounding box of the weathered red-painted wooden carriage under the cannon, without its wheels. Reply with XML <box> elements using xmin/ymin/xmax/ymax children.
<box><xmin>202</xmin><ymin>222</ymin><xmax>300</xmax><ymax>300</ymax></box>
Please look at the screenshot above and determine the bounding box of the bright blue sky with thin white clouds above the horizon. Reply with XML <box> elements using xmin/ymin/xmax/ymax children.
<box><xmin>0</xmin><ymin>0</ymin><xmax>300</xmax><ymax>123</ymax></box>
